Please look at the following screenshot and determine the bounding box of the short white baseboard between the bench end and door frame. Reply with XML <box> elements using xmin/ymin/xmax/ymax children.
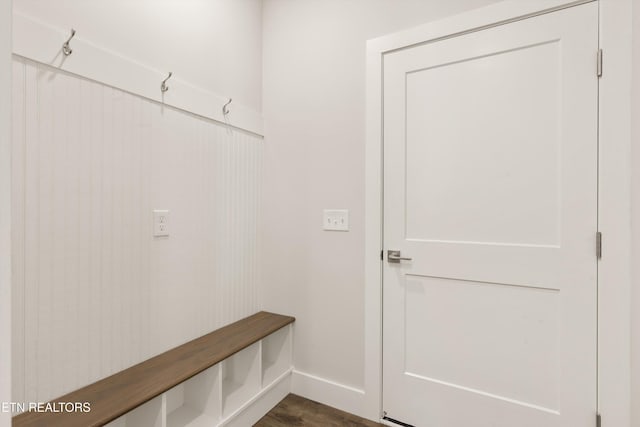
<box><xmin>291</xmin><ymin>370</ymin><xmax>364</xmax><ymax>419</ymax></box>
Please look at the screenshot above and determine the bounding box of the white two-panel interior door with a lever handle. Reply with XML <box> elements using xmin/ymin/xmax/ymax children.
<box><xmin>383</xmin><ymin>3</ymin><xmax>598</xmax><ymax>427</ymax></box>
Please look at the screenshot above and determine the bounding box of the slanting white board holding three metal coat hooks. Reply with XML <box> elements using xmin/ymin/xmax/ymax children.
<box><xmin>13</xmin><ymin>13</ymin><xmax>264</xmax><ymax>136</ymax></box>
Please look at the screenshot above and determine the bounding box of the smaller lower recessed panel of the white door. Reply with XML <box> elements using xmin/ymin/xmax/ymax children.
<box><xmin>404</xmin><ymin>276</ymin><xmax>558</xmax><ymax>411</ymax></box>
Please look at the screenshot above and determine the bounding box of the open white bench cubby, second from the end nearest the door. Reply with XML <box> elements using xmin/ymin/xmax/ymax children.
<box><xmin>221</xmin><ymin>342</ymin><xmax>261</xmax><ymax>417</ymax></box>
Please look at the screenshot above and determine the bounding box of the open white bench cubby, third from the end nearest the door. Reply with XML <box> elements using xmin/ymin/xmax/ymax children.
<box><xmin>166</xmin><ymin>364</ymin><xmax>222</xmax><ymax>427</ymax></box>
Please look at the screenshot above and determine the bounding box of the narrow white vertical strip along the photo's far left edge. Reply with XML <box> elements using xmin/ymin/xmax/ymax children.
<box><xmin>0</xmin><ymin>0</ymin><xmax>11</xmax><ymax>426</ymax></box>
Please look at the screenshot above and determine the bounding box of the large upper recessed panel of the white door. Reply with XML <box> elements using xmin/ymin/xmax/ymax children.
<box><xmin>406</xmin><ymin>40</ymin><xmax>560</xmax><ymax>246</ymax></box>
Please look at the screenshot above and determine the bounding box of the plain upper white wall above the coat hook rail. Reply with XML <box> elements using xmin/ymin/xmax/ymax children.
<box><xmin>14</xmin><ymin>0</ymin><xmax>262</xmax><ymax>111</ymax></box>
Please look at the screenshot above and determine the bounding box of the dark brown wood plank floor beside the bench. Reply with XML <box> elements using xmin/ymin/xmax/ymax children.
<box><xmin>254</xmin><ymin>394</ymin><xmax>382</xmax><ymax>427</ymax></box>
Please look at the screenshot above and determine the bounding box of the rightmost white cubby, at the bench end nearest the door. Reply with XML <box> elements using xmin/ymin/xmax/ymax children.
<box><xmin>262</xmin><ymin>325</ymin><xmax>291</xmax><ymax>387</ymax></box>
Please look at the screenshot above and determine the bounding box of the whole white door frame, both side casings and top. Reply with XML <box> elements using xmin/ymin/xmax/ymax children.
<box><xmin>362</xmin><ymin>0</ymin><xmax>632</xmax><ymax>427</ymax></box>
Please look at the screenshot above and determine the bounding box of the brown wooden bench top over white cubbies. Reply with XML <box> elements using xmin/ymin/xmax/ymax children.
<box><xmin>12</xmin><ymin>311</ymin><xmax>295</xmax><ymax>427</ymax></box>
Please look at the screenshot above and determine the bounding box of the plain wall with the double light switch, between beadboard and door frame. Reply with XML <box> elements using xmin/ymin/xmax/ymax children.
<box><xmin>263</xmin><ymin>0</ymin><xmax>500</xmax><ymax>412</ymax></box>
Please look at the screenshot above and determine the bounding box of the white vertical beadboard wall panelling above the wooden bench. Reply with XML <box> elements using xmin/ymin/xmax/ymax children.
<box><xmin>12</xmin><ymin>58</ymin><xmax>263</xmax><ymax>408</ymax></box>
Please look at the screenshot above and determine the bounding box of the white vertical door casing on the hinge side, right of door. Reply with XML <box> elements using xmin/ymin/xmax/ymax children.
<box><xmin>598</xmin><ymin>0</ymin><xmax>632</xmax><ymax>427</ymax></box>
